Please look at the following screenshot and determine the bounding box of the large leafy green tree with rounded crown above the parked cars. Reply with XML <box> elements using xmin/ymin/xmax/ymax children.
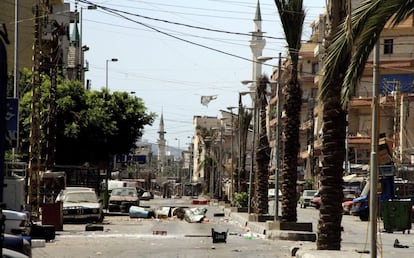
<box><xmin>20</xmin><ymin>77</ymin><xmax>155</xmax><ymax>165</ymax></box>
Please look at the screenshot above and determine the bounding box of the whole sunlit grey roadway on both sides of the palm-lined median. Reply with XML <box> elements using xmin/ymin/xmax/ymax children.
<box><xmin>32</xmin><ymin>197</ymin><xmax>414</xmax><ymax>258</ymax></box>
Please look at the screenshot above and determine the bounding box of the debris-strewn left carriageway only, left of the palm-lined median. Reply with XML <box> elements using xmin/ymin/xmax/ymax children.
<box><xmin>32</xmin><ymin>198</ymin><xmax>293</xmax><ymax>258</ymax></box>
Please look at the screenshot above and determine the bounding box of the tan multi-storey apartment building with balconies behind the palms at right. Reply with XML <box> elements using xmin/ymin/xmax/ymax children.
<box><xmin>269</xmin><ymin>5</ymin><xmax>414</xmax><ymax>184</ymax></box>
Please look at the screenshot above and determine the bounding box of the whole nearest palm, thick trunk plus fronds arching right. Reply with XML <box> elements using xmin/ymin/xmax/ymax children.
<box><xmin>317</xmin><ymin>0</ymin><xmax>414</xmax><ymax>250</ymax></box>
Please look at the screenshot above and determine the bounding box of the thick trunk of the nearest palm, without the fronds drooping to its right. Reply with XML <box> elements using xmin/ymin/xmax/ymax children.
<box><xmin>317</xmin><ymin>0</ymin><xmax>352</xmax><ymax>250</ymax></box>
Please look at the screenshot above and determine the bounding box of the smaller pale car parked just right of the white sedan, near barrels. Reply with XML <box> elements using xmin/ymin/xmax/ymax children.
<box><xmin>108</xmin><ymin>187</ymin><xmax>139</xmax><ymax>213</ymax></box>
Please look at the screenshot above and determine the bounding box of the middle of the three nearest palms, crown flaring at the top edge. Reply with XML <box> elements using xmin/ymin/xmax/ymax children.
<box><xmin>275</xmin><ymin>0</ymin><xmax>305</xmax><ymax>222</ymax></box>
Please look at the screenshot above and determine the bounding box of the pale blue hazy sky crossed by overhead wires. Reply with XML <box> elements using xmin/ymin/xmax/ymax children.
<box><xmin>73</xmin><ymin>0</ymin><xmax>325</xmax><ymax>152</ymax></box>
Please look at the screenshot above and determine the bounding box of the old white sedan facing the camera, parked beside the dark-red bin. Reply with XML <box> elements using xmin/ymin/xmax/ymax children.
<box><xmin>61</xmin><ymin>189</ymin><xmax>104</xmax><ymax>222</ymax></box>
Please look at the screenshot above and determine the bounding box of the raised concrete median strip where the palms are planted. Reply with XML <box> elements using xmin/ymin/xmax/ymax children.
<box><xmin>210</xmin><ymin>202</ymin><xmax>369</xmax><ymax>258</ymax></box>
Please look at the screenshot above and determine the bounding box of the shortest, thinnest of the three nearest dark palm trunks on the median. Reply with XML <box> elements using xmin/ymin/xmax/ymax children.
<box><xmin>254</xmin><ymin>76</ymin><xmax>270</xmax><ymax>214</ymax></box>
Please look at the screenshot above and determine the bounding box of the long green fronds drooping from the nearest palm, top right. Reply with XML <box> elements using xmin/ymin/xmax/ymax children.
<box><xmin>319</xmin><ymin>0</ymin><xmax>414</xmax><ymax>108</ymax></box>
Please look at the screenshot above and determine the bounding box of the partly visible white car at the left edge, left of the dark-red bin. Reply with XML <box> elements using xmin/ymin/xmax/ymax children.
<box><xmin>2</xmin><ymin>210</ymin><xmax>30</xmax><ymax>234</ymax></box>
